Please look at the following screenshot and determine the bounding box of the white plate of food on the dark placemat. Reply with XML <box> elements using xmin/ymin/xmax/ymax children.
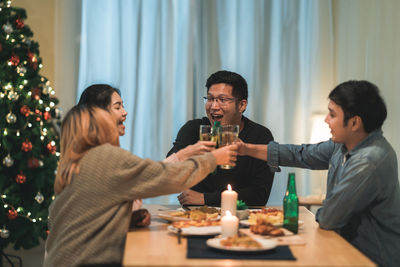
<box><xmin>207</xmin><ymin>235</ymin><xmax>277</xmax><ymax>252</ymax></box>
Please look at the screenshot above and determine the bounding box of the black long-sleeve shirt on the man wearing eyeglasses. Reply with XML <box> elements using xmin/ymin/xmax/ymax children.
<box><xmin>167</xmin><ymin>116</ymin><xmax>274</xmax><ymax>206</ymax></box>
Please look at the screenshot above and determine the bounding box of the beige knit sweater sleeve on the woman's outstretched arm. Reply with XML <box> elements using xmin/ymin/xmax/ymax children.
<box><xmin>80</xmin><ymin>144</ymin><xmax>216</xmax><ymax>200</ymax></box>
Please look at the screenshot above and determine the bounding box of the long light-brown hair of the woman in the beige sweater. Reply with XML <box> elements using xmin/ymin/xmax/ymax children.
<box><xmin>54</xmin><ymin>105</ymin><xmax>119</xmax><ymax>195</ymax></box>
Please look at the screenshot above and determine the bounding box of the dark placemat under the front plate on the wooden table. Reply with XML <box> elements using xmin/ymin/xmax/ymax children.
<box><xmin>186</xmin><ymin>236</ymin><xmax>296</xmax><ymax>260</ymax></box>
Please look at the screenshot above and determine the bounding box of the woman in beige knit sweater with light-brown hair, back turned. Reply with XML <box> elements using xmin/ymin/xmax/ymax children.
<box><xmin>44</xmin><ymin>106</ymin><xmax>237</xmax><ymax>266</ymax></box>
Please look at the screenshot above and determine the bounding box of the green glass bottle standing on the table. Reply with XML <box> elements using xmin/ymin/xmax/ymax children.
<box><xmin>283</xmin><ymin>173</ymin><xmax>299</xmax><ymax>234</ymax></box>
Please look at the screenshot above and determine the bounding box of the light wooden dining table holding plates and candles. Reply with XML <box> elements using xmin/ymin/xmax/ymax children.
<box><xmin>123</xmin><ymin>205</ymin><xmax>376</xmax><ymax>267</ymax></box>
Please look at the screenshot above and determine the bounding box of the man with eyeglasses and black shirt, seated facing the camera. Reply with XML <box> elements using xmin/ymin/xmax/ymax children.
<box><xmin>167</xmin><ymin>71</ymin><xmax>274</xmax><ymax>206</ymax></box>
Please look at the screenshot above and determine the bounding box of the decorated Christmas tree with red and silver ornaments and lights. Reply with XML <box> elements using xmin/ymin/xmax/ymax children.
<box><xmin>0</xmin><ymin>0</ymin><xmax>60</xmax><ymax>249</ymax></box>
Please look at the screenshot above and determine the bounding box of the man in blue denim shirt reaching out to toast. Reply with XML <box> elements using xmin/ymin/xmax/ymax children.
<box><xmin>239</xmin><ymin>81</ymin><xmax>400</xmax><ymax>266</ymax></box>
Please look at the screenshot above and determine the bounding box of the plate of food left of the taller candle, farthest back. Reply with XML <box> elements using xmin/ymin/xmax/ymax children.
<box><xmin>157</xmin><ymin>206</ymin><xmax>220</xmax><ymax>222</ymax></box>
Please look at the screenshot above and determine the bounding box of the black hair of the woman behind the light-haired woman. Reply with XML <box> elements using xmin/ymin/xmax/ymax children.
<box><xmin>78</xmin><ymin>84</ymin><xmax>121</xmax><ymax>110</ymax></box>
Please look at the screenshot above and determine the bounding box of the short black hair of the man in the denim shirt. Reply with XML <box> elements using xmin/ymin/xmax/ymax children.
<box><xmin>329</xmin><ymin>81</ymin><xmax>387</xmax><ymax>133</ymax></box>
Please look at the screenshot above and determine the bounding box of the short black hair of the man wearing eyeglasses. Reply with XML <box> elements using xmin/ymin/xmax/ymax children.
<box><xmin>206</xmin><ymin>70</ymin><xmax>248</xmax><ymax>101</ymax></box>
